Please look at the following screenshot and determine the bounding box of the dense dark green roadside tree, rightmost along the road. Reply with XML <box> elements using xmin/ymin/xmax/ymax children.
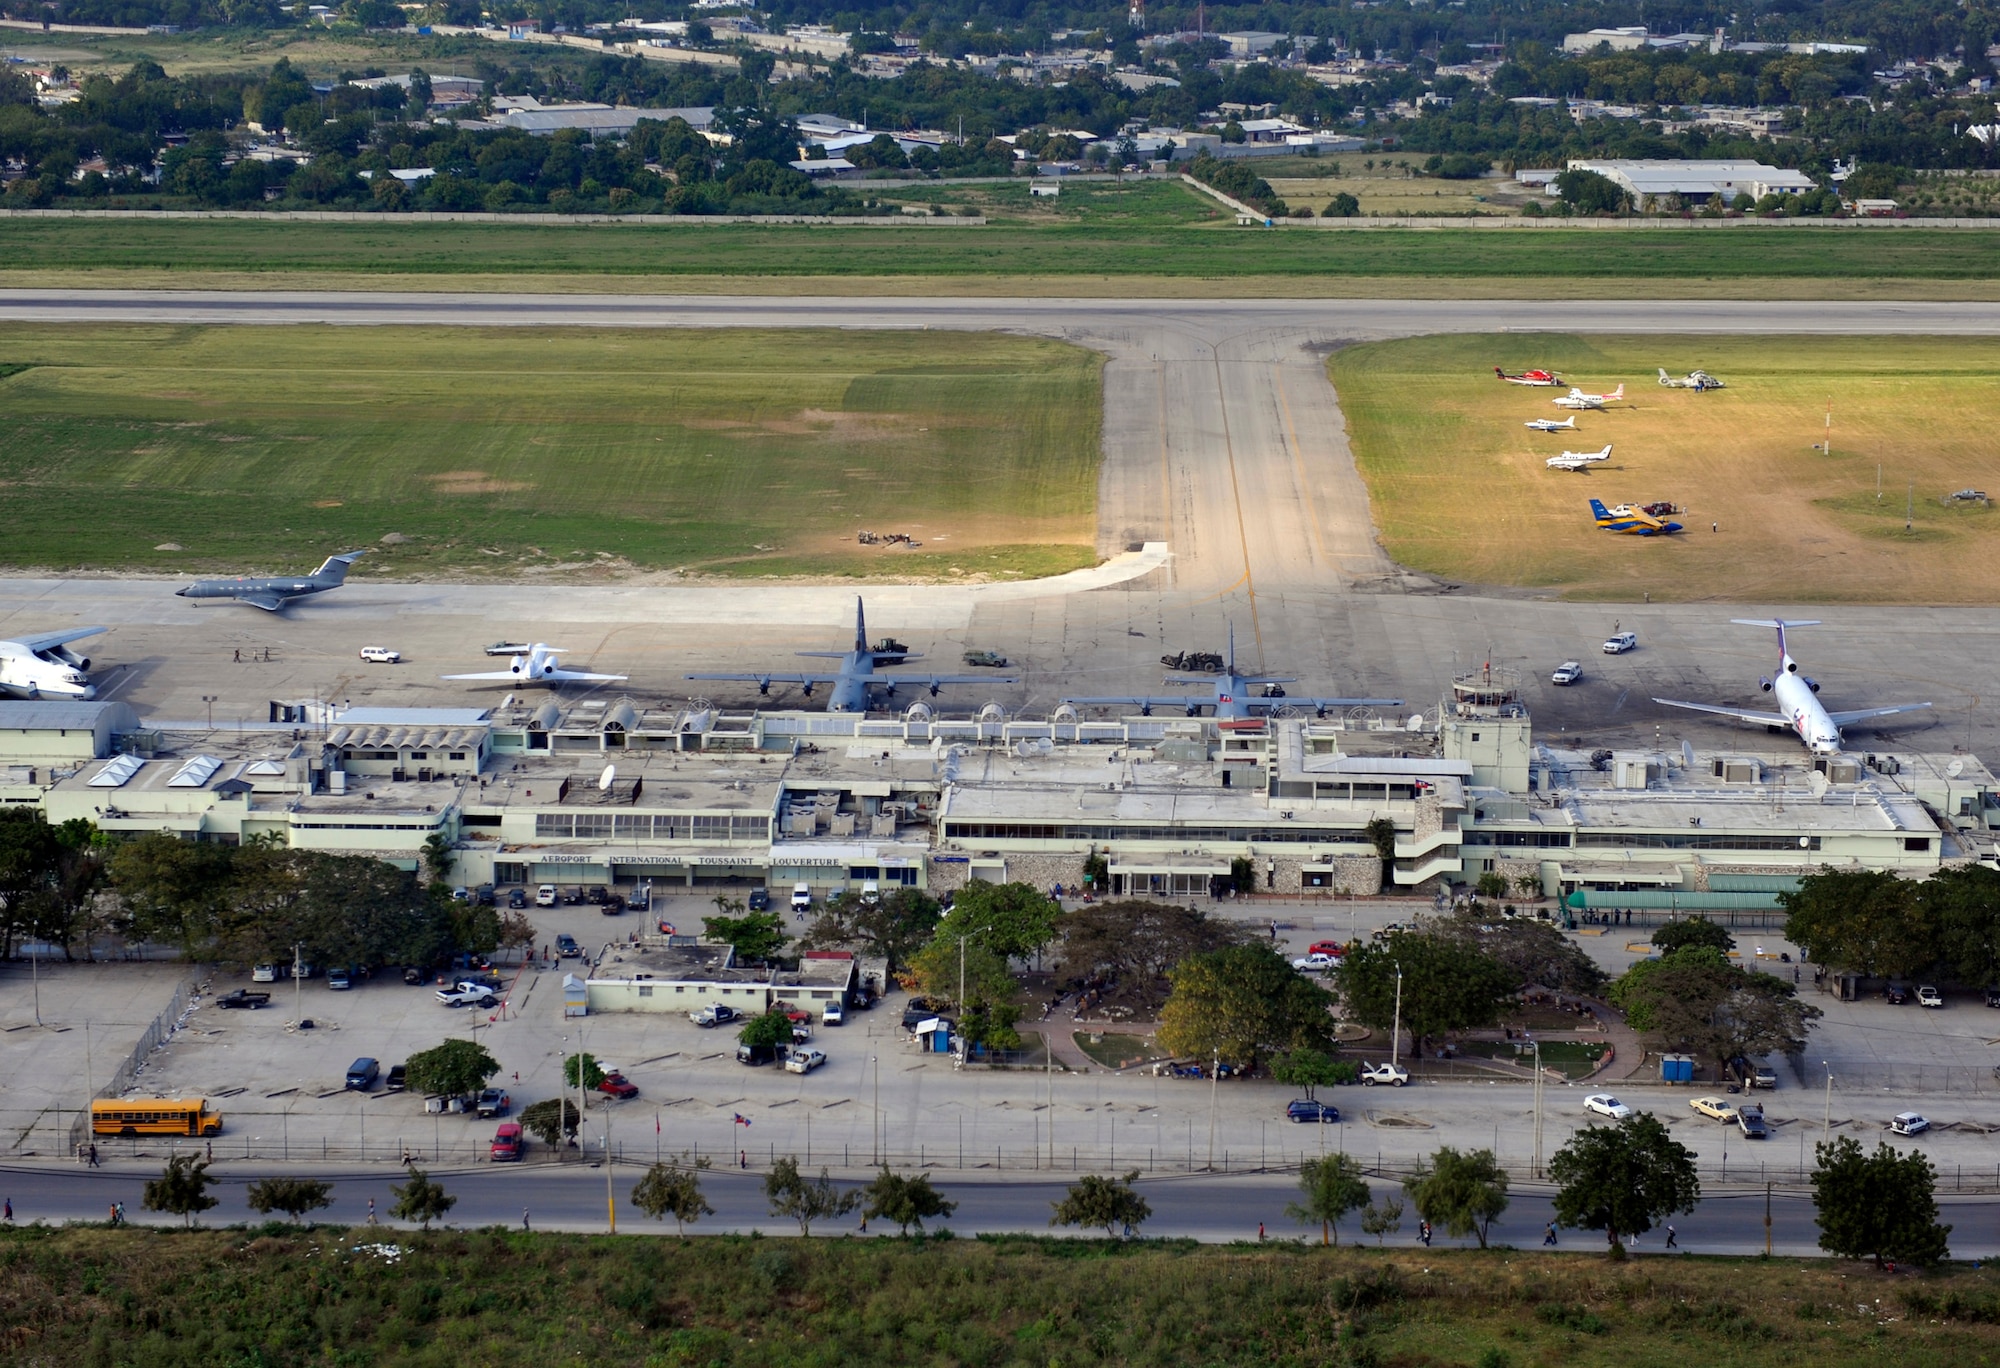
<box><xmin>1812</xmin><ymin>1136</ymin><xmax>1952</xmax><ymax>1268</ymax></box>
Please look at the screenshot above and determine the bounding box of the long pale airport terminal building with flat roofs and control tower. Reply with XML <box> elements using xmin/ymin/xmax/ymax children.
<box><xmin>0</xmin><ymin>674</ymin><xmax>2000</xmax><ymax>910</ymax></box>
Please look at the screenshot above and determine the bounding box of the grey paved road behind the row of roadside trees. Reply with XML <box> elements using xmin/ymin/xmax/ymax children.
<box><xmin>0</xmin><ymin>1164</ymin><xmax>2000</xmax><ymax>1258</ymax></box>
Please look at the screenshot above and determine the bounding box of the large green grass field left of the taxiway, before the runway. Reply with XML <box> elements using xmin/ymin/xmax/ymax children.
<box><xmin>0</xmin><ymin>324</ymin><xmax>1100</xmax><ymax>578</ymax></box>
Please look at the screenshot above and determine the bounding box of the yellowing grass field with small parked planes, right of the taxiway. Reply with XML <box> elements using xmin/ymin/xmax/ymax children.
<box><xmin>1330</xmin><ymin>334</ymin><xmax>2000</xmax><ymax>604</ymax></box>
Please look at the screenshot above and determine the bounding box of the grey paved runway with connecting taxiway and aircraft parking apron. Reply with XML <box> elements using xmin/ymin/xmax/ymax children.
<box><xmin>0</xmin><ymin>290</ymin><xmax>2000</xmax><ymax>754</ymax></box>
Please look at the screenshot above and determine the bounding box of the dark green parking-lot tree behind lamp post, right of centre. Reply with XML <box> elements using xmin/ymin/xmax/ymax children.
<box><xmin>1334</xmin><ymin>932</ymin><xmax>1522</xmax><ymax>1054</ymax></box>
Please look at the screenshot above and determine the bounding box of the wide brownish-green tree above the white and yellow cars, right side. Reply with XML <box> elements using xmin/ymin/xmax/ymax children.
<box><xmin>1608</xmin><ymin>946</ymin><xmax>1820</xmax><ymax>1064</ymax></box>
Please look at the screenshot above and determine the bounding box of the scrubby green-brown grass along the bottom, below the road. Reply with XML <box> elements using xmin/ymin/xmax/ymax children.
<box><xmin>0</xmin><ymin>1226</ymin><xmax>2000</xmax><ymax>1368</ymax></box>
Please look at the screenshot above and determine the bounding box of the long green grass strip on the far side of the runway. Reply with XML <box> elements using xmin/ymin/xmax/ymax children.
<box><xmin>0</xmin><ymin>216</ymin><xmax>2000</xmax><ymax>290</ymax></box>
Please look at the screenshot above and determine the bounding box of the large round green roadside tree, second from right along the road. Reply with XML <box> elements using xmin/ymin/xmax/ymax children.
<box><xmin>1548</xmin><ymin>1112</ymin><xmax>1702</xmax><ymax>1246</ymax></box>
